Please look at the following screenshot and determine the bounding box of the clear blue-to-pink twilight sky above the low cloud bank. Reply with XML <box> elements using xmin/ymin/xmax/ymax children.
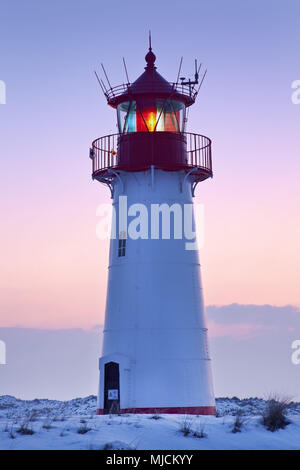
<box><xmin>0</xmin><ymin>0</ymin><xmax>300</xmax><ymax>329</ymax></box>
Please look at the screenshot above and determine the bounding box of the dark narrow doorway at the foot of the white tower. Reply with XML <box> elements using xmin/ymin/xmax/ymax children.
<box><xmin>104</xmin><ymin>362</ymin><xmax>120</xmax><ymax>414</ymax></box>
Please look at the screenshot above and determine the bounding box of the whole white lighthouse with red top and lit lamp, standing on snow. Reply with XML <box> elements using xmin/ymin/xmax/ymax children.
<box><xmin>90</xmin><ymin>43</ymin><xmax>215</xmax><ymax>415</ymax></box>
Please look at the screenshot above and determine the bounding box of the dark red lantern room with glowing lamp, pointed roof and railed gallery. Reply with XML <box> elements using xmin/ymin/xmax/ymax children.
<box><xmin>91</xmin><ymin>47</ymin><xmax>212</xmax><ymax>181</ymax></box>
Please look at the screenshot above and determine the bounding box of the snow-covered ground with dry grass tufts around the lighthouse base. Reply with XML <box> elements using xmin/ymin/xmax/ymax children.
<box><xmin>0</xmin><ymin>396</ymin><xmax>300</xmax><ymax>450</ymax></box>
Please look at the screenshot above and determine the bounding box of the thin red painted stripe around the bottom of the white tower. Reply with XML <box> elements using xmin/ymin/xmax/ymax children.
<box><xmin>96</xmin><ymin>406</ymin><xmax>216</xmax><ymax>416</ymax></box>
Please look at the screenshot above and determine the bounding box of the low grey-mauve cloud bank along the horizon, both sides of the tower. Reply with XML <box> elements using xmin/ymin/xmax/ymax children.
<box><xmin>0</xmin><ymin>304</ymin><xmax>300</xmax><ymax>401</ymax></box>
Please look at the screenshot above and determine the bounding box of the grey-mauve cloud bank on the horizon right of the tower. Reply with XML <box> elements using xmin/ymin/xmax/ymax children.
<box><xmin>207</xmin><ymin>304</ymin><xmax>300</xmax><ymax>400</ymax></box>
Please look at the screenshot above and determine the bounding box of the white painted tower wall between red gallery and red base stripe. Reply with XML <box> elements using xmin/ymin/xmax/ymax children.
<box><xmin>98</xmin><ymin>170</ymin><xmax>214</xmax><ymax>408</ymax></box>
